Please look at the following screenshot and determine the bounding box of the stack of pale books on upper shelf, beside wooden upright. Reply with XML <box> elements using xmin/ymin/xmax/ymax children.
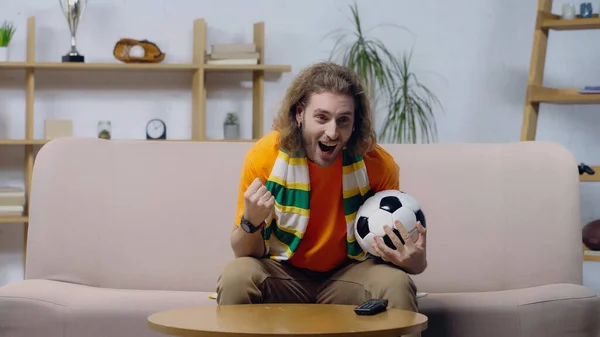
<box><xmin>206</xmin><ymin>43</ymin><xmax>259</xmax><ymax>65</ymax></box>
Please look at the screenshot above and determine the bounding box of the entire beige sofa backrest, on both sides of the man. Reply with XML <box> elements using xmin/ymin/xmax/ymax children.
<box><xmin>26</xmin><ymin>139</ymin><xmax>582</xmax><ymax>292</ymax></box>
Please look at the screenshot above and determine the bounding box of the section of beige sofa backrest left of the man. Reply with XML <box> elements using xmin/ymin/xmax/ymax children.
<box><xmin>26</xmin><ymin>138</ymin><xmax>252</xmax><ymax>291</ymax></box>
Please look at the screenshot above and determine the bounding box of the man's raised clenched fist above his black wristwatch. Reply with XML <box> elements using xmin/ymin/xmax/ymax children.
<box><xmin>244</xmin><ymin>178</ymin><xmax>275</xmax><ymax>226</ymax></box>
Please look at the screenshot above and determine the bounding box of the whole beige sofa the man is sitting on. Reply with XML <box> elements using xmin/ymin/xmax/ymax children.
<box><xmin>0</xmin><ymin>135</ymin><xmax>600</xmax><ymax>337</ymax></box>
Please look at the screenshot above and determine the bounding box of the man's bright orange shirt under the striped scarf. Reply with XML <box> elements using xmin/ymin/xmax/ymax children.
<box><xmin>235</xmin><ymin>131</ymin><xmax>399</xmax><ymax>271</ymax></box>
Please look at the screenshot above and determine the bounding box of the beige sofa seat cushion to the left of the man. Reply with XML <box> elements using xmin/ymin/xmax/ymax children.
<box><xmin>0</xmin><ymin>280</ymin><xmax>216</xmax><ymax>337</ymax></box>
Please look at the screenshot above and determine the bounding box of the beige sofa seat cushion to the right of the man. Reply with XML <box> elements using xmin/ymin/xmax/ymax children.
<box><xmin>419</xmin><ymin>284</ymin><xmax>600</xmax><ymax>337</ymax></box>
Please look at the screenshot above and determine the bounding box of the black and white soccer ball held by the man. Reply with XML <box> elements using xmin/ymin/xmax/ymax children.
<box><xmin>354</xmin><ymin>190</ymin><xmax>427</xmax><ymax>256</ymax></box>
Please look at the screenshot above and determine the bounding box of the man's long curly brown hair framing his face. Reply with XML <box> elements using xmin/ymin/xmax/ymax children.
<box><xmin>273</xmin><ymin>62</ymin><xmax>377</xmax><ymax>156</ymax></box>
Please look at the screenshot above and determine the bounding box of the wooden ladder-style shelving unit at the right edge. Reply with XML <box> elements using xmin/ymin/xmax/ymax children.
<box><xmin>521</xmin><ymin>0</ymin><xmax>600</xmax><ymax>261</ymax></box>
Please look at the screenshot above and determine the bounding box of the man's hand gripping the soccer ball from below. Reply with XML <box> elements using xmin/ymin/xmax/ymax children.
<box><xmin>373</xmin><ymin>220</ymin><xmax>427</xmax><ymax>274</ymax></box>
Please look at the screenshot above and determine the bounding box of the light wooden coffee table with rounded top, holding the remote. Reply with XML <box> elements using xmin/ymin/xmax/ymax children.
<box><xmin>148</xmin><ymin>304</ymin><xmax>427</xmax><ymax>337</ymax></box>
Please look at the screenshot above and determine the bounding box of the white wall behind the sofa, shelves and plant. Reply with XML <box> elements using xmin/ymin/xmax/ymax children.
<box><xmin>0</xmin><ymin>0</ymin><xmax>600</xmax><ymax>291</ymax></box>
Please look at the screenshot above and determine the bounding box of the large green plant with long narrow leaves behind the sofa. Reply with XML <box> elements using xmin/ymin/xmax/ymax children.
<box><xmin>328</xmin><ymin>3</ymin><xmax>441</xmax><ymax>143</ymax></box>
